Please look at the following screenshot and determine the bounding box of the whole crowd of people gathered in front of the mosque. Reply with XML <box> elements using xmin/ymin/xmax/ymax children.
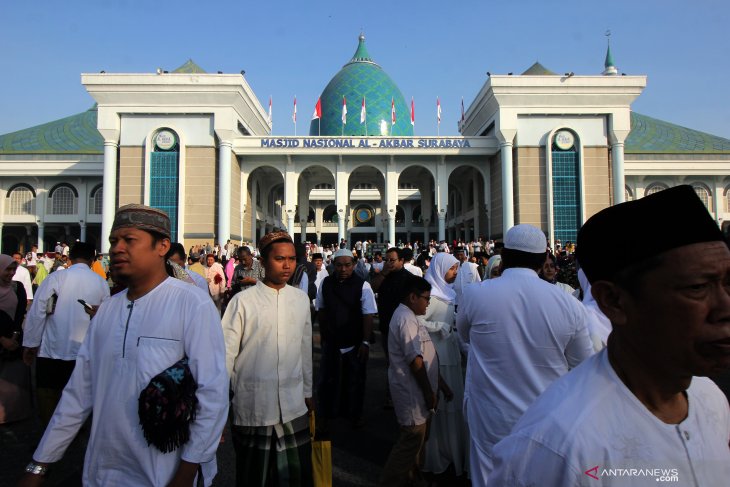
<box><xmin>0</xmin><ymin>186</ymin><xmax>730</xmax><ymax>486</ymax></box>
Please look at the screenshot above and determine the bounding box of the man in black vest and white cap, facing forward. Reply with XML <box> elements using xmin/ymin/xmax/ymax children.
<box><xmin>316</xmin><ymin>249</ymin><xmax>378</xmax><ymax>433</ymax></box>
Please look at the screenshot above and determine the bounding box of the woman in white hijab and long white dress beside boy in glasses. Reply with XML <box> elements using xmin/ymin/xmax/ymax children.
<box><xmin>419</xmin><ymin>252</ymin><xmax>469</xmax><ymax>476</ymax></box>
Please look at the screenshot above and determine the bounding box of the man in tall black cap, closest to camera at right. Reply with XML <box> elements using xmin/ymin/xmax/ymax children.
<box><xmin>489</xmin><ymin>186</ymin><xmax>730</xmax><ymax>486</ymax></box>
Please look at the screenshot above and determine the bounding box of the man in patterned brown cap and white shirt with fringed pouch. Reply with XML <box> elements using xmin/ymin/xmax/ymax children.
<box><xmin>19</xmin><ymin>204</ymin><xmax>228</xmax><ymax>487</ymax></box>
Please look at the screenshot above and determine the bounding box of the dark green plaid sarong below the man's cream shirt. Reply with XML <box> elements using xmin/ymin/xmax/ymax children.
<box><xmin>231</xmin><ymin>414</ymin><xmax>313</xmax><ymax>487</ymax></box>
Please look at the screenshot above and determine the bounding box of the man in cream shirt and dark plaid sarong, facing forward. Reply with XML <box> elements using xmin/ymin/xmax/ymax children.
<box><xmin>223</xmin><ymin>232</ymin><xmax>313</xmax><ymax>487</ymax></box>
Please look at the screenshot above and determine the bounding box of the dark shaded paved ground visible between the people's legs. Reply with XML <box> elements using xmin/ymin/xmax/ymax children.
<box><xmin>0</xmin><ymin>320</ymin><xmax>466</xmax><ymax>487</ymax></box>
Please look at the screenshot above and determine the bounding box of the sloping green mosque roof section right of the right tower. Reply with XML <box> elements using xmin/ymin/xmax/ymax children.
<box><xmin>624</xmin><ymin>112</ymin><xmax>730</xmax><ymax>154</ymax></box>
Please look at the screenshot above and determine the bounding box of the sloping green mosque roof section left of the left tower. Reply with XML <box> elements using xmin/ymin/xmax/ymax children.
<box><xmin>0</xmin><ymin>105</ymin><xmax>104</xmax><ymax>154</ymax></box>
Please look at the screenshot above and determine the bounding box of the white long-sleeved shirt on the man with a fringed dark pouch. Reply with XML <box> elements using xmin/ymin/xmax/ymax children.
<box><xmin>33</xmin><ymin>271</ymin><xmax>228</xmax><ymax>487</ymax></box>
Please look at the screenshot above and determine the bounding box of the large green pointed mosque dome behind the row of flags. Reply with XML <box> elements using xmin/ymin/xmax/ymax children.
<box><xmin>309</xmin><ymin>34</ymin><xmax>413</xmax><ymax>137</ymax></box>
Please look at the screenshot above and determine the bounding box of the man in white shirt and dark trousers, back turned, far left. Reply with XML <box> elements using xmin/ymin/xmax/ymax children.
<box><xmin>23</xmin><ymin>242</ymin><xmax>109</xmax><ymax>426</ymax></box>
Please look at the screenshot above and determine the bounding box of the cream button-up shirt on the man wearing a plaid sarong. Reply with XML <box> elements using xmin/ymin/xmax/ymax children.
<box><xmin>223</xmin><ymin>281</ymin><xmax>312</xmax><ymax>426</ymax></box>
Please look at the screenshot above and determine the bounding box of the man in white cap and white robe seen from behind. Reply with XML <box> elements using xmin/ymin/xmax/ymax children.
<box><xmin>456</xmin><ymin>224</ymin><xmax>593</xmax><ymax>487</ymax></box>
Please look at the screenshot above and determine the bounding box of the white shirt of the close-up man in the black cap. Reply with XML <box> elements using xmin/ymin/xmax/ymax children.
<box><xmin>489</xmin><ymin>349</ymin><xmax>730</xmax><ymax>487</ymax></box>
